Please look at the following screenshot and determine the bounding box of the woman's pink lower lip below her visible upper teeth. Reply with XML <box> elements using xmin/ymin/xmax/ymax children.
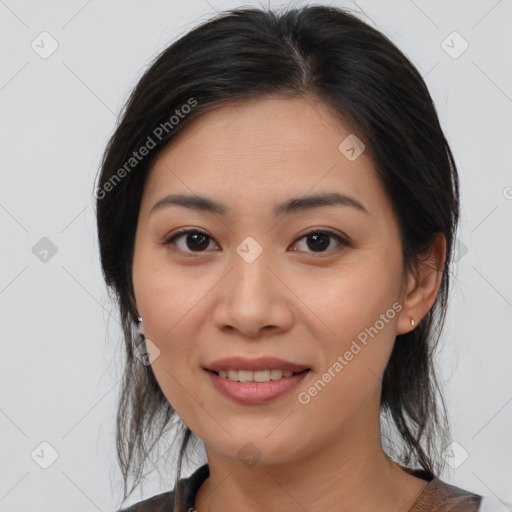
<box><xmin>205</xmin><ymin>370</ymin><xmax>310</xmax><ymax>404</ymax></box>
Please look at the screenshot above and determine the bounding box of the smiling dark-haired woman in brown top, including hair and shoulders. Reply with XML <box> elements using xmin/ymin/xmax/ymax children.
<box><xmin>96</xmin><ymin>6</ymin><xmax>496</xmax><ymax>512</ymax></box>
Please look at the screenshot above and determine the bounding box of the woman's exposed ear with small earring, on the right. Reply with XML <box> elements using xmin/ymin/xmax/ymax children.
<box><xmin>397</xmin><ymin>233</ymin><xmax>446</xmax><ymax>334</ymax></box>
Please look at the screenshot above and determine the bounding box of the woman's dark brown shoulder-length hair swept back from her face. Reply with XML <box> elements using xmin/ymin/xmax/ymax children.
<box><xmin>95</xmin><ymin>5</ymin><xmax>459</xmax><ymax>510</ymax></box>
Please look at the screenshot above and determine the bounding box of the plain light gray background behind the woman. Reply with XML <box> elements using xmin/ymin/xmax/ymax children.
<box><xmin>0</xmin><ymin>0</ymin><xmax>512</xmax><ymax>512</ymax></box>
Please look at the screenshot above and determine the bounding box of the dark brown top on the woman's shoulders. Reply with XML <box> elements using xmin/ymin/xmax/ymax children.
<box><xmin>118</xmin><ymin>464</ymin><xmax>482</xmax><ymax>512</ymax></box>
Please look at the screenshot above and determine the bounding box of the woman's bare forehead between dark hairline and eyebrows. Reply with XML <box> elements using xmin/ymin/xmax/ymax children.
<box><xmin>145</xmin><ymin>96</ymin><xmax>390</xmax><ymax>221</ymax></box>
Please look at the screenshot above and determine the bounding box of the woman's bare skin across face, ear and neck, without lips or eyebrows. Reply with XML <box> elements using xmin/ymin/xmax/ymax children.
<box><xmin>133</xmin><ymin>96</ymin><xmax>446</xmax><ymax>512</ymax></box>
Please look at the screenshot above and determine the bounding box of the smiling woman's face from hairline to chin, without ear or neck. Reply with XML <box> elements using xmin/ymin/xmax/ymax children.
<box><xmin>133</xmin><ymin>97</ymin><xmax>416</xmax><ymax>463</ymax></box>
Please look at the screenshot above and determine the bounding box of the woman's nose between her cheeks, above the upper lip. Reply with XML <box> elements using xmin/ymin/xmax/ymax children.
<box><xmin>214</xmin><ymin>245</ymin><xmax>293</xmax><ymax>338</ymax></box>
